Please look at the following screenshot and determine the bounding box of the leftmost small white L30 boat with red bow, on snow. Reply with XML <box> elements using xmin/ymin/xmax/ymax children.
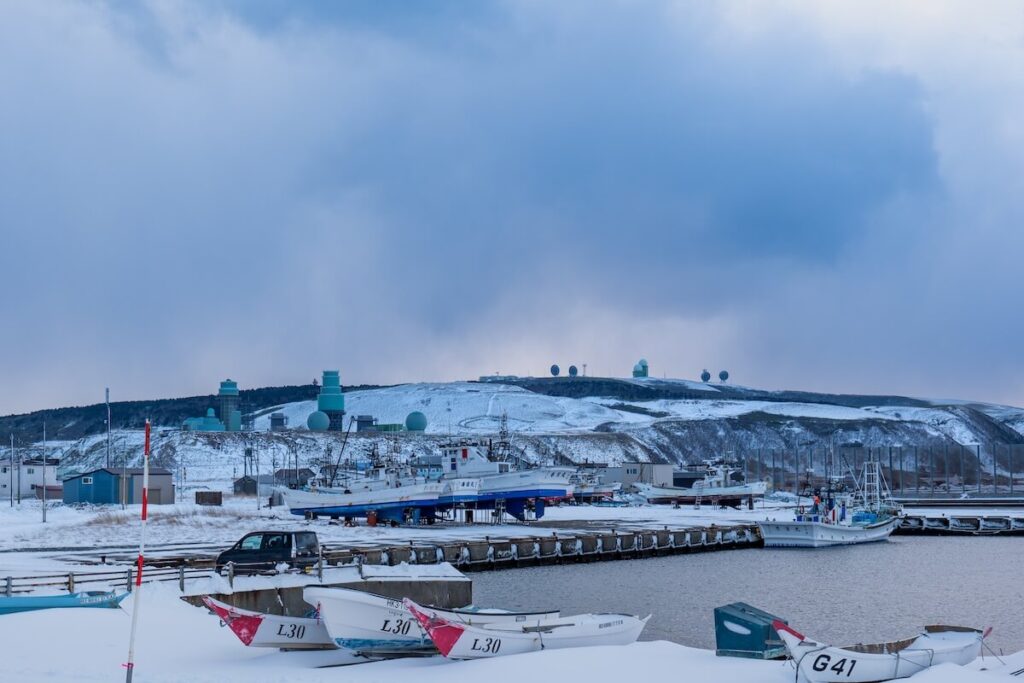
<box><xmin>203</xmin><ymin>595</ymin><xmax>337</xmax><ymax>650</ymax></box>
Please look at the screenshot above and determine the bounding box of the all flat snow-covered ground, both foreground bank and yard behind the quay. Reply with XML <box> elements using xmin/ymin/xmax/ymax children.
<box><xmin>0</xmin><ymin>499</ymin><xmax>1024</xmax><ymax>683</ymax></box>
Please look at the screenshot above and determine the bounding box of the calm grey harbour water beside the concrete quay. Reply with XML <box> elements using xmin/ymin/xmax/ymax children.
<box><xmin>471</xmin><ymin>537</ymin><xmax>1024</xmax><ymax>652</ymax></box>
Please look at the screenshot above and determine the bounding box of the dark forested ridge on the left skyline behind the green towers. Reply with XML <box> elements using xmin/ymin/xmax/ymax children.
<box><xmin>0</xmin><ymin>384</ymin><xmax>376</xmax><ymax>443</ymax></box>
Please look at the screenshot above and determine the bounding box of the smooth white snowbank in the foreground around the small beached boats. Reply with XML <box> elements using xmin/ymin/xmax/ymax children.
<box><xmin>0</xmin><ymin>587</ymin><xmax>1024</xmax><ymax>683</ymax></box>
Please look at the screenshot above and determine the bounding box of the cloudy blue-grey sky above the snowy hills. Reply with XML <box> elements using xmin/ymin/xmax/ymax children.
<box><xmin>0</xmin><ymin>0</ymin><xmax>1024</xmax><ymax>413</ymax></box>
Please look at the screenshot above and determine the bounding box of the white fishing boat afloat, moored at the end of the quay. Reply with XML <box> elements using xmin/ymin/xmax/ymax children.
<box><xmin>758</xmin><ymin>461</ymin><xmax>901</xmax><ymax>548</ymax></box>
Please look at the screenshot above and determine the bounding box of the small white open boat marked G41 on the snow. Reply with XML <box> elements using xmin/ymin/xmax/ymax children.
<box><xmin>772</xmin><ymin>620</ymin><xmax>988</xmax><ymax>683</ymax></box>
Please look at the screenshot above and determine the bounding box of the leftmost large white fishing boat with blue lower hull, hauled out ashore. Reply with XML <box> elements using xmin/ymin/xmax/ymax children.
<box><xmin>282</xmin><ymin>465</ymin><xmax>445</xmax><ymax>522</ymax></box>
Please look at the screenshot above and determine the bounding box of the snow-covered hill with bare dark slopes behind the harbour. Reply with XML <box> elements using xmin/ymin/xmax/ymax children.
<box><xmin>37</xmin><ymin>380</ymin><xmax>1024</xmax><ymax>488</ymax></box>
